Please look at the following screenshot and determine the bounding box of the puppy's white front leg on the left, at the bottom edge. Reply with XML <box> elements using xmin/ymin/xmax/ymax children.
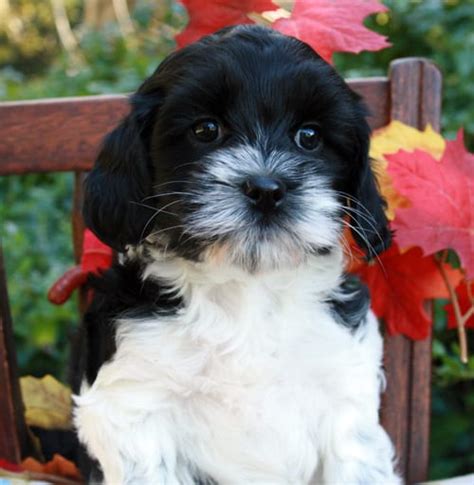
<box><xmin>74</xmin><ymin>386</ymin><xmax>182</xmax><ymax>485</ymax></box>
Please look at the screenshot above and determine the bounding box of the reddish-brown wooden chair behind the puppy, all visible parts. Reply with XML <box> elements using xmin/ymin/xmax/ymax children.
<box><xmin>0</xmin><ymin>58</ymin><xmax>441</xmax><ymax>483</ymax></box>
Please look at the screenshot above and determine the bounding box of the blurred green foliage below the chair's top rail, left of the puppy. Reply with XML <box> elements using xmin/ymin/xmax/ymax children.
<box><xmin>0</xmin><ymin>174</ymin><xmax>77</xmax><ymax>376</ymax></box>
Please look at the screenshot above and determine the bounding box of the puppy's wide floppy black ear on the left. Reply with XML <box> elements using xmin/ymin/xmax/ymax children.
<box><xmin>83</xmin><ymin>96</ymin><xmax>159</xmax><ymax>251</ymax></box>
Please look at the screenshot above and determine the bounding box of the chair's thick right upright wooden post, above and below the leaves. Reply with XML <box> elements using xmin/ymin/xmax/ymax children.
<box><xmin>382</xmin><ymin>58</ymin><xmax>441</xmax><ymax>483</ymax></box>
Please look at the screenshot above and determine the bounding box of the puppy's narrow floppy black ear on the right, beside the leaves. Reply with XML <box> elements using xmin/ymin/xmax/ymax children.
<box><xmin>348</xmin><ymin>116</ymin><xmax>392</xmax><ymax>260</ymax></box>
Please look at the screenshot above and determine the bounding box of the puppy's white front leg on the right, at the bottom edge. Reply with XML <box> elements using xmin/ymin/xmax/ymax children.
<box><xmin>322</xmin><ymin>412</ymin><xmax>402</xmax><ymax>485</ymax></box>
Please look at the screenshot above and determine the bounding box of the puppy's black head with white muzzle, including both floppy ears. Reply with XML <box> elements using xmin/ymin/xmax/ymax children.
<box><xmin>84</xmin><ymin>26</ymin><xmax>390</xmax><ymax>270</ymax></box>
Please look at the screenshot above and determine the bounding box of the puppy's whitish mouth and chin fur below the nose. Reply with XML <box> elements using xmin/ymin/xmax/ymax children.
<box><xmin>148</xmin><ymin>199</ymin><xmax>340</xmax><ymax>273</ymax></box>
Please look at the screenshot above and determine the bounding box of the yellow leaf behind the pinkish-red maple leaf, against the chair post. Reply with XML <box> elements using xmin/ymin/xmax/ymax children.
<box><xmin>370</xmin><ymin>121</ymin><xmax>446</xmax><ymax>220</ymax></box>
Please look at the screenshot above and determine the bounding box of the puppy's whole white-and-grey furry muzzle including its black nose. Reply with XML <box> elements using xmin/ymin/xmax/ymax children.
<box><xmin>146</xmin><ymin>146</ymin><xmax>342</xmax><ymax>271</ymax></box>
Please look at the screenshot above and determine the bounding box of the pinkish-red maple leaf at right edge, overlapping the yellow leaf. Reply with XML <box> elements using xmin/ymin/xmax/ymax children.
<box><xmin>386</xmin><ymin>131</ymin><xmax>474</xmax><ymax>277</ymax></box>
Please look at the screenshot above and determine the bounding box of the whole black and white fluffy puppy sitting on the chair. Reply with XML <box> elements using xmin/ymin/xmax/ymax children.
<box><xmin>75</xmin><ymin>26</ymin><xmax>400</xmax><ymax>485</ymax></box>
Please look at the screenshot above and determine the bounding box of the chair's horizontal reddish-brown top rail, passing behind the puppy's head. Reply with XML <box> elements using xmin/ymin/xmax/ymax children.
<box><xmin>0</xmin><ymin>78</ymin><xmax>389</xmax><ymax>175</ymax></box>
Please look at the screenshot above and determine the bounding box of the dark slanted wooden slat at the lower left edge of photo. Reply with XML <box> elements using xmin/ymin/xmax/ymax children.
<box><xmin>0</xmin><ymin>245</ymin><xmax>27</xmax><ymax>463</ymax></box>
